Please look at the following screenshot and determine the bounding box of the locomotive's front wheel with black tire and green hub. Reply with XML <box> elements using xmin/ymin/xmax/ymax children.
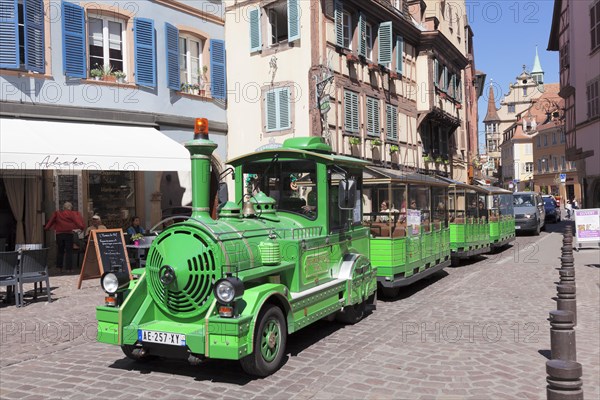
<box><xmin>240</xmin><ymin>304</ymin><xmax>287</xmax><ymax>377</ymax></box>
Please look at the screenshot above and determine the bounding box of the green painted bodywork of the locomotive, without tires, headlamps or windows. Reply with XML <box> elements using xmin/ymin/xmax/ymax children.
<box><xmin>96</xmin><ymin>137</ymin><xmax>377</xmax><ymax>360</ymax></box>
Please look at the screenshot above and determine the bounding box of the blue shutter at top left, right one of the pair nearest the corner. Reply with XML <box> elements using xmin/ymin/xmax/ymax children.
<box><xmin>23</xmin><ymin>0</ymin><xmax>46</xmax><ymax>74</ymax></box>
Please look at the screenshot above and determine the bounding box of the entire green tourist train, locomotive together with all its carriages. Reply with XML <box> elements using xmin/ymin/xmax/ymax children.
<box><xmin>96</xmin><ymin>122</ymin><xmax>514</xmax><ymax>376</ymax></box>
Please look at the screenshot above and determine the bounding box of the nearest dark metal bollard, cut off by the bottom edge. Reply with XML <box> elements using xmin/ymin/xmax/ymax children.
<box><xmin>546</xmin><ymin>360</ymin><xmax>583</xmax><ymax>400</ymax></box>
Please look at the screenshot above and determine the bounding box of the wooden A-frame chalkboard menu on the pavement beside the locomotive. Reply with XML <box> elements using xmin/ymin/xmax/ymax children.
<box><xmin>77</xmin><ymin>229</ymin><xmax>131</xmax><ymax>289</ymax></box>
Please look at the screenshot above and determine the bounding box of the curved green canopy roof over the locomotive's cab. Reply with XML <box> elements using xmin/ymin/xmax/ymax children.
<box><xmin>227</xmin><ymin>137</ymin><xmax>369</xmax><ymax>168</ymax></box>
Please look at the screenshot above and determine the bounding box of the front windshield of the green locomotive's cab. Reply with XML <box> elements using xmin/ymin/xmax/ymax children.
<box><xmin>243</xmin><ymin>160</ymin><xmax>318</xmax><ymax>220</ymax></box>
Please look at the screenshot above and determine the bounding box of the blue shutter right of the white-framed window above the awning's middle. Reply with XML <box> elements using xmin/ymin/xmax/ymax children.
<box><xmin>133</xmin><ymin>18</ymin><xmax>156</xmax><ymax>87</ymax></box>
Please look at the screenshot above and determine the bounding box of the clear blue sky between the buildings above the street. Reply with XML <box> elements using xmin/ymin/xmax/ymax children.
<box><xmin>466</xmin><ymin>0</ymin><xmax>559</xmax><ymax>153</ymax></box>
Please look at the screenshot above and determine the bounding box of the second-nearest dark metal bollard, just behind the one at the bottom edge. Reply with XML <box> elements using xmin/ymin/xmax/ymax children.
<box><xmin>548</xmin><ymin>310</ymin><xmax>577</xmax><ymax>361</ymax></box>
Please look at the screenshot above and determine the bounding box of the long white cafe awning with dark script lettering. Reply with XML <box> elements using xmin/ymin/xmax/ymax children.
<box><xmin>0</xmin><ymin>118</ymin><xmax>192</xmax><ymax>171</ymax></box>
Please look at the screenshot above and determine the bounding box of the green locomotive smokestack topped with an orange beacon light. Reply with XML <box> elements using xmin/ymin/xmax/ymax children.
<box><xmin>185</xmin><ymin>118</ymin><xmax>217</xmax><ymax>218</ymax></box>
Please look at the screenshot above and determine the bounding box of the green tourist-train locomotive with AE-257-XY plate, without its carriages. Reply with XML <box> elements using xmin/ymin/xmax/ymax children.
<box><xmin>96</xmin><ymin>133</ymin><xmax>377</xmax><ymax>376</ymax></box>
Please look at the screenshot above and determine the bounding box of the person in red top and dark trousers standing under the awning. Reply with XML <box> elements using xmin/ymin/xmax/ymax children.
<box><xmin>44</xmin><ymin>201</ymin><xmax>85</xmax><ymax>271</ymax></box>
